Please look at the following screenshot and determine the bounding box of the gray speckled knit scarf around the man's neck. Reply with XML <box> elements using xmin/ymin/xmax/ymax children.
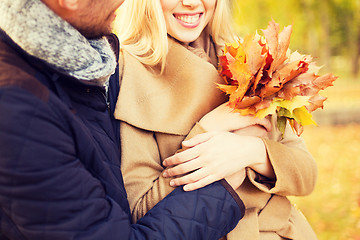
<box><xmin>0</xmin><ymin>0</ymin><xmax>116</xmax><ymax>85</ymax></box>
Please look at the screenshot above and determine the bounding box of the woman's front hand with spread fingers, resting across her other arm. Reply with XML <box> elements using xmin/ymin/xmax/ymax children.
<box><xmin>163</xmin><ymin>132</ymin><xmax>272</xmax><ymax>191</ymax></box>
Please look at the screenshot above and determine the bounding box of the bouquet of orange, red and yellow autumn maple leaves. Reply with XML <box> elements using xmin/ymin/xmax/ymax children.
<box><xmin>218</xmin><ymin>21</ymin><xmax>337</xmax><ymax>135</ymax></box>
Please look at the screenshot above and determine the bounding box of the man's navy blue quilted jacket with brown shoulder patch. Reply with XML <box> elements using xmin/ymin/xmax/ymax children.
<box><xmin>0</xmin><ymin>32</ymin><xmax>244</xmax><ymax>240</ymax></box>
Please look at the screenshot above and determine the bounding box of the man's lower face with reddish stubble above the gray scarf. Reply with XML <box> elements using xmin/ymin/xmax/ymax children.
<box><xmin>42</xmin><ymin>0</ymin><xmax>124</xmax><ymax>38</ymax></box>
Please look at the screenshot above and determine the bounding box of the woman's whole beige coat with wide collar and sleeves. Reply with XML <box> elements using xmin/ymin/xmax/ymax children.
<box><xmin>115</xmin><ymin>40</ymin><xmax>317</xmax><ymax>240</ymax></box>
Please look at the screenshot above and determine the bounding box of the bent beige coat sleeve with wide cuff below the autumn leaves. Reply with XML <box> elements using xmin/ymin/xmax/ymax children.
<box><xmin>247</xmin><ymin>116</ymin><xmax>317</xmax><ymax>196</ymax></box>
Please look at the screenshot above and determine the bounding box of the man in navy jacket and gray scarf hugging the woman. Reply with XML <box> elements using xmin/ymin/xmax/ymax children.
<box><xmin>0</xmin><ymin>0</ymin><xmax>244</xmax><ymax>239</ymax></box>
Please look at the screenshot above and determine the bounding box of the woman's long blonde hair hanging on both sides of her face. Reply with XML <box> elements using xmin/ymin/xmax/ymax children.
<box><xmin>115</xmin><ymin>0</ymin><xmax>236</xmax><ymax>69</ymax></box>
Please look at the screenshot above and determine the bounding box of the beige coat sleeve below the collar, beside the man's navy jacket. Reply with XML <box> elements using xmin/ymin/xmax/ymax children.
<box><xmin>120</xmin><ymin>122</ymin><xmax>174</xmax><ymax>222</ymax></box>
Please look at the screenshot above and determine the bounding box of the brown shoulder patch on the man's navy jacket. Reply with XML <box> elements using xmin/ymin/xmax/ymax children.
<box><xmin>0</xmin><ymin>40</ymin><xmax>48</xmax><ymax>99</ymax></box>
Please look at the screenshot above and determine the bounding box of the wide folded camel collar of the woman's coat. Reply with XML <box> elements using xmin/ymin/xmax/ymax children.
<box><xmin>115</xmin><ymin>39</ymin><xmax>227</xmax><ymax>135</ymax></box>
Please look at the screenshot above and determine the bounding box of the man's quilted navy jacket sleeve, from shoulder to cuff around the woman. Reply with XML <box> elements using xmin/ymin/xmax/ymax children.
<box><xmin>0</xmin><ymin>87</ymin><xmax>243</xmax><ymax>239</ymax></box>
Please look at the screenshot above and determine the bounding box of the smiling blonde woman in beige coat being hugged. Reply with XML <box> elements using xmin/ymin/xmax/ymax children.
<box><xmin>115</xmin><ymin>0</ymin><xmax>317</xmax><ymax>240</ymax></box>
